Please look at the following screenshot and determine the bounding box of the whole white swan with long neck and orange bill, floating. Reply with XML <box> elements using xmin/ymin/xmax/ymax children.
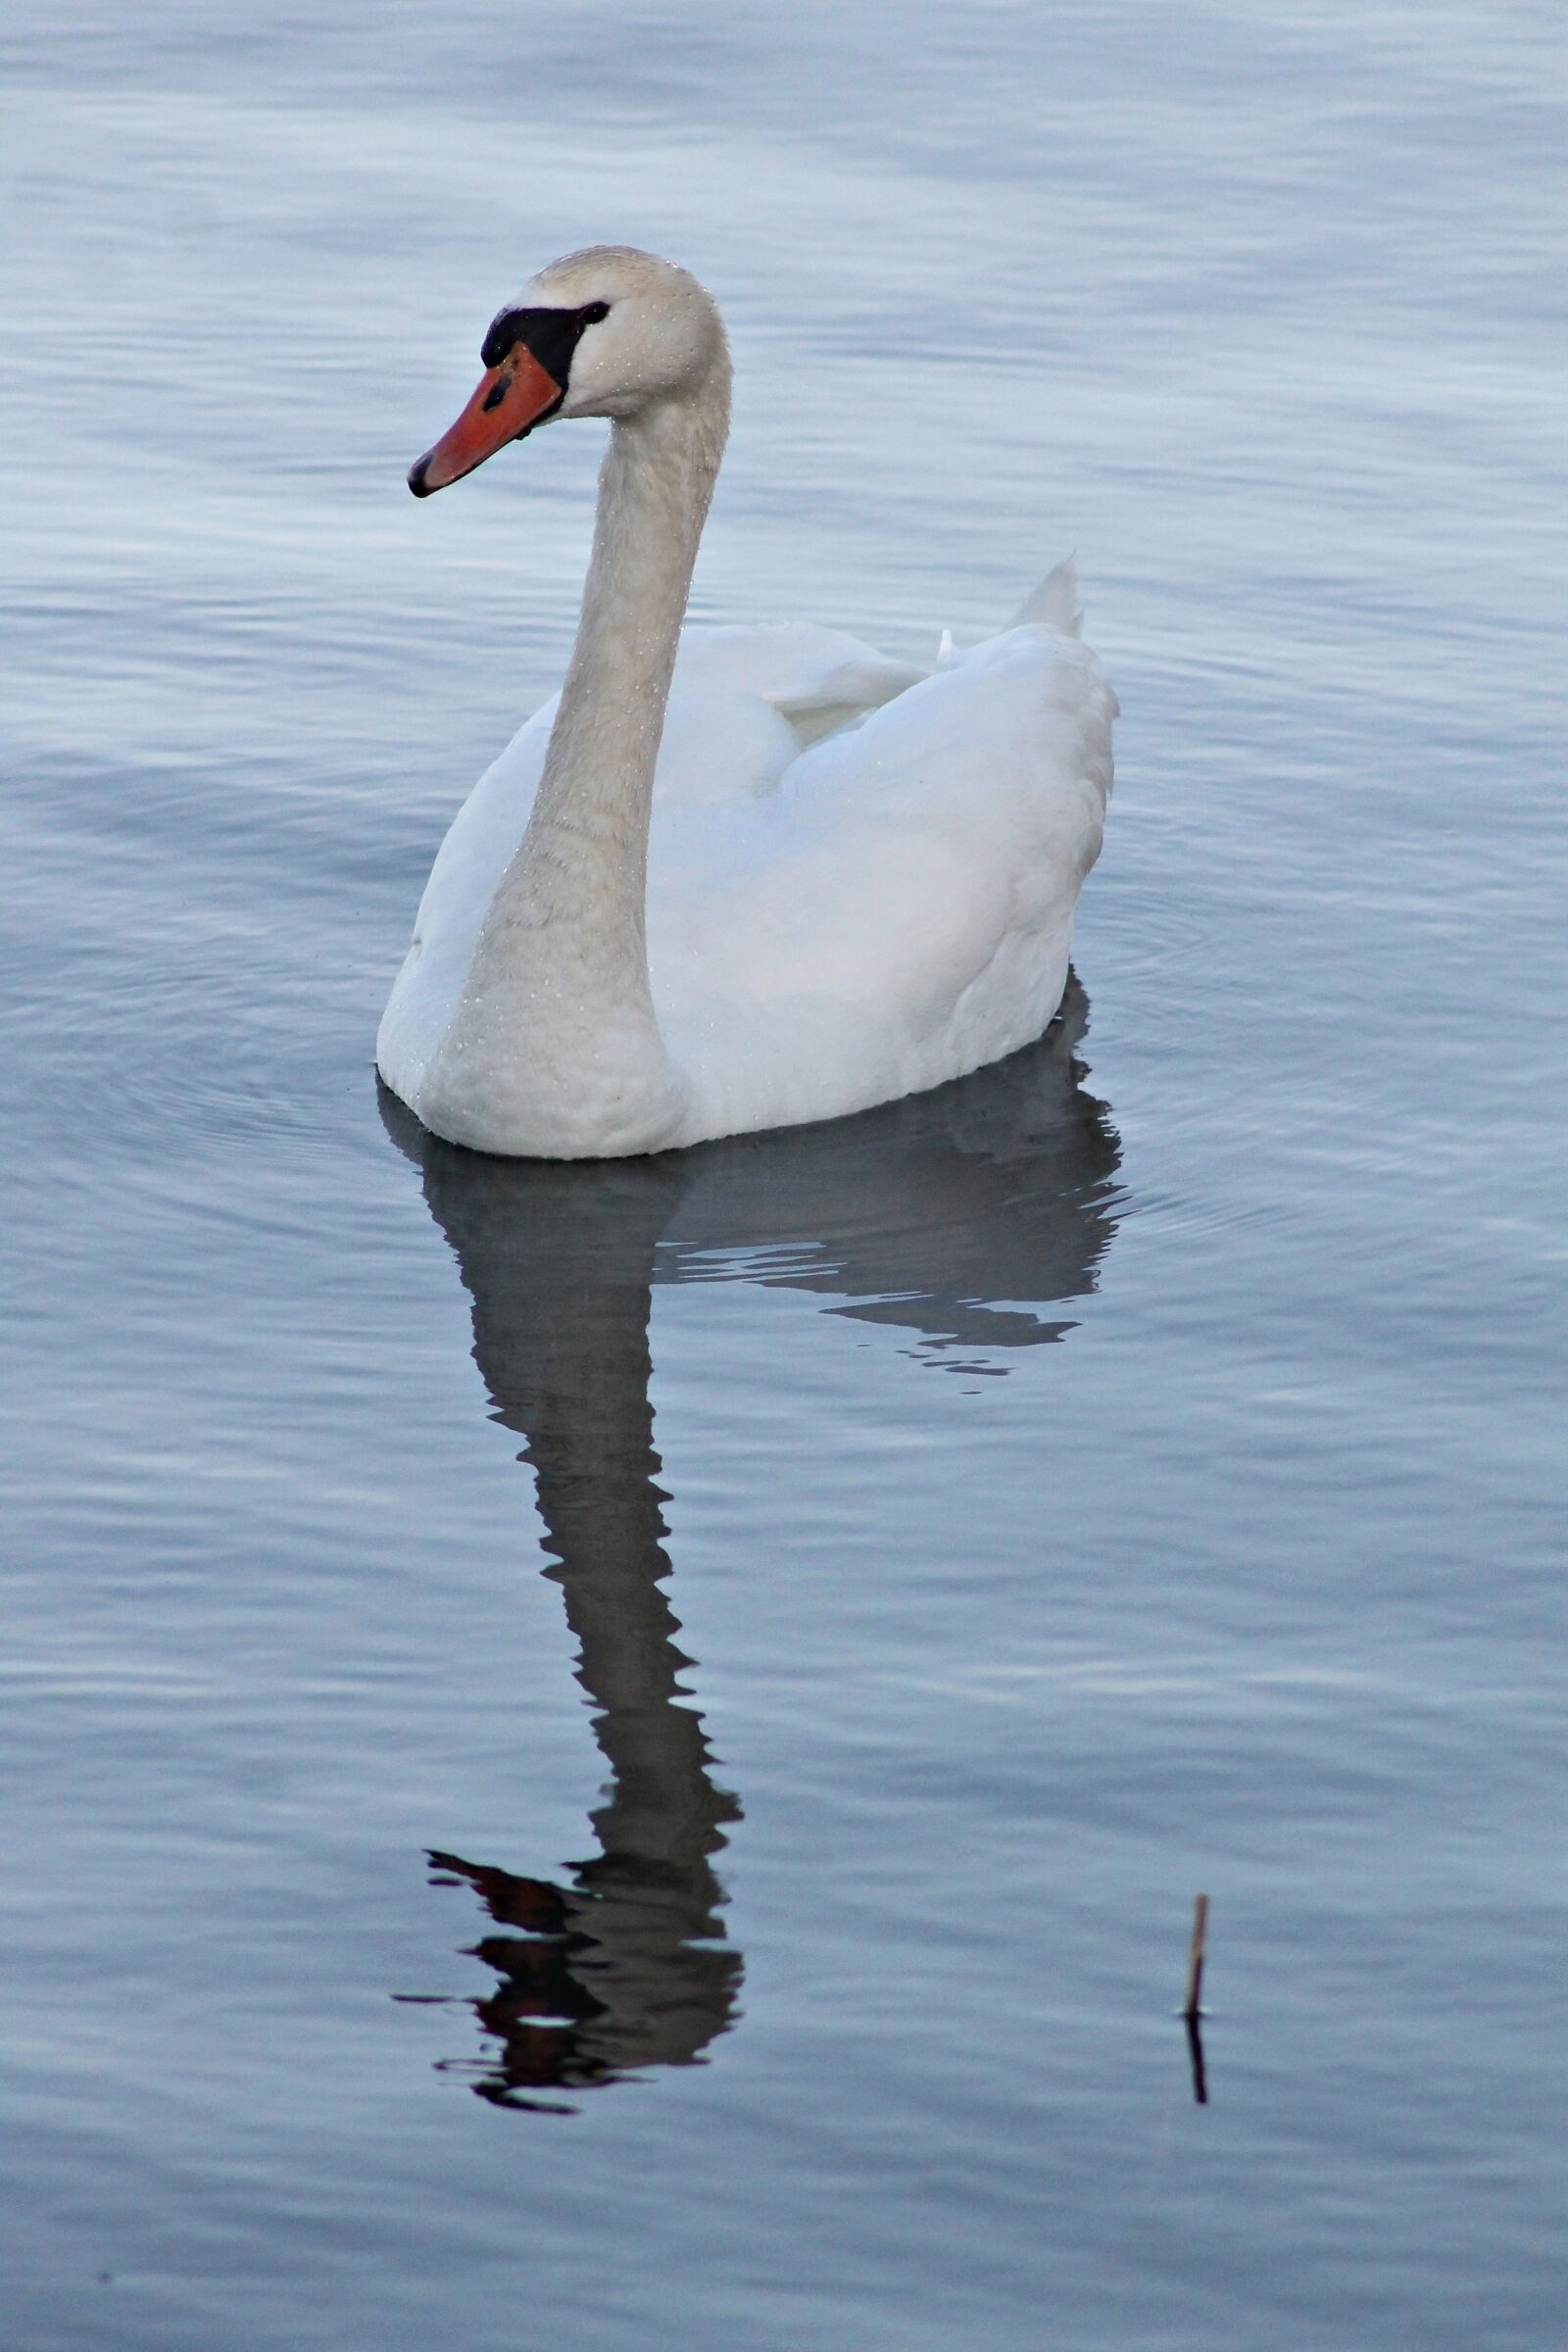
<box><xmin>376</xmin><ymin>247</ymin><xmax>1116</xmax><ymax>1159</ymax></box>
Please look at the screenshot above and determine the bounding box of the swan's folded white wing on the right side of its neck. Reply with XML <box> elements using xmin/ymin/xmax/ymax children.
<box><xmin>649</xmin><ymin>621</ymin><xmax>1114</xmax><ymax>1141</ymax></box>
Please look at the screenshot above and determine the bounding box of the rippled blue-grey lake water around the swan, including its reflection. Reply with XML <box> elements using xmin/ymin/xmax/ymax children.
<box><xmin>0</xmin><ymin>0</ymin><xmax>1568</xmax><ymax>2352</ymax></box>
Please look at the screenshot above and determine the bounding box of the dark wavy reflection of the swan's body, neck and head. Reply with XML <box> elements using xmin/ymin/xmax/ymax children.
<box><xmin>381</xmin><ymin>983</ymin><xmax>1119</xmax><ymax>2107</ymax></box>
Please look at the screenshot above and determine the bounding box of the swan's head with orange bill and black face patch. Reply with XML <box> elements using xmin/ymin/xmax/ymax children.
<box><xmin>409</xmin><ymin>245</ymin><xmax>729</xmax><ymax>499</ymax></box>
